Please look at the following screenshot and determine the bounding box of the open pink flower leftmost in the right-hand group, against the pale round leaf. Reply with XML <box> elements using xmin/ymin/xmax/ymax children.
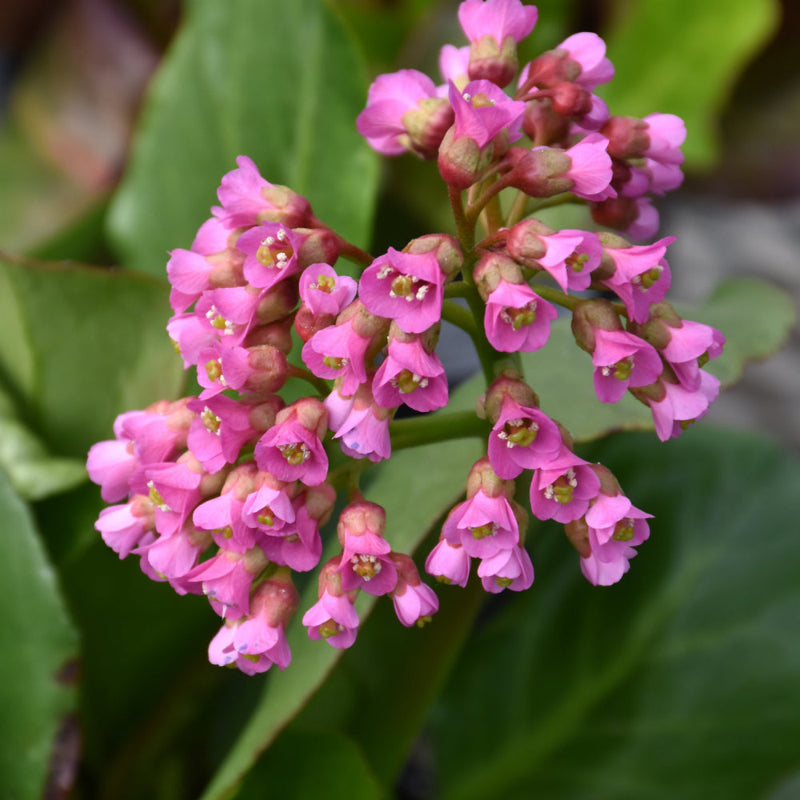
<box><xmin>592</xmin><ymin>328</ymin><xmax>663</xmax><ymax>403</ymax></box>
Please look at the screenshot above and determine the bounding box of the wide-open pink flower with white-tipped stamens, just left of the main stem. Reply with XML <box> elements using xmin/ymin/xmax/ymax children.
<box><xmin>359</xmin><ymin>252</ymin><xmax>445</xmax><ymax>333</ymax></box>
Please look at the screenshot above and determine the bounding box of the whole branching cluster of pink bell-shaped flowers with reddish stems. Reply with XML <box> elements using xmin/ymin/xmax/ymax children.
<box><xmin>87</xmin><ymin>0</ymin><xmax>724</xmax><ymax>674</ymax></box>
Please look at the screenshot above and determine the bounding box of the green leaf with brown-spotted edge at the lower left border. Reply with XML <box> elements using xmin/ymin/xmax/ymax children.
<box><xmin>0</xmin><ymin>471</ymin><xmax>78</xmax><ymax>800</ymax></box>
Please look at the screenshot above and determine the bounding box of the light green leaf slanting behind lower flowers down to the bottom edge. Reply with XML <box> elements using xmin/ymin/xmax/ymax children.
<box><xmin>198</xmin><ymin>432</ymin><xmax>481</xmax><ymax>800</ymax></box>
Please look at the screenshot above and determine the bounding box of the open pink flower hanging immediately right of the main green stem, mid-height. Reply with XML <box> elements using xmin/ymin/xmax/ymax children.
<box><xmin>483</xmin><ymin>279</ymin><xmax>558</xmax><ymax>353</ymax></box>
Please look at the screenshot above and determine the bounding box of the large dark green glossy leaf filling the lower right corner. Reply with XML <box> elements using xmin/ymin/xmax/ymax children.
<box><xmin>430</xmin><ymin>428</ymin><xmax>800</xmax><ymax>800</ymax></box>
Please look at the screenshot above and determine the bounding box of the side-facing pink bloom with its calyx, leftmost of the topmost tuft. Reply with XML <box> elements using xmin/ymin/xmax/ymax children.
<box><xmin>356</xmin><ymin>69</ymin><xmax>453</xmax><ymax>158</ymax></box>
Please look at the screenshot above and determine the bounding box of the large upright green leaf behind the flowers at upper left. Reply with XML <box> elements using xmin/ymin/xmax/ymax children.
<box><xmin>109</xmin><ymin>0</ymin><xmax>377</xmax><ymax>275</ymax></box>
